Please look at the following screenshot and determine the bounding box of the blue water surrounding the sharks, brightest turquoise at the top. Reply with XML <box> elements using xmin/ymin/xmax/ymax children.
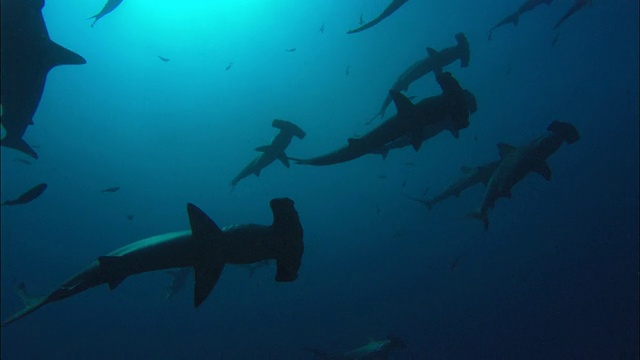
<box><xmin>1</xmin><ymin>0</ymin><xmax>640</xmax><ymax>359</ymax></box>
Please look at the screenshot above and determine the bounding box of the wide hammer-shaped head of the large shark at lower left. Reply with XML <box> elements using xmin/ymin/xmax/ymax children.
<box><xmin>269</xmin><ymin>198</ymin><xmax>304</xmax><ymax>282</ymax></box>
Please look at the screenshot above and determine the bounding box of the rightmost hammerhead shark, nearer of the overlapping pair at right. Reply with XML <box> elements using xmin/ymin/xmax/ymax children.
<box><xmin>470</xmin><ymin>121</ymin><xmax>580</xmax><ymax>230</ymax></box>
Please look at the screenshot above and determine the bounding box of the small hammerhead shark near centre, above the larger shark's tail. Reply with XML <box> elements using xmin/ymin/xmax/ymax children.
<box><xmin>231</xmin><ymin>119</ymin><xmax>306</xmax><ymax>187</ymax></box>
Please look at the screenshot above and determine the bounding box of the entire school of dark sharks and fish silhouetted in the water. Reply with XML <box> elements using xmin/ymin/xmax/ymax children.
<box><xmin>1</xmin><ymin>0</ymin><xmax>616</xmax><ymax>359</ymax></box>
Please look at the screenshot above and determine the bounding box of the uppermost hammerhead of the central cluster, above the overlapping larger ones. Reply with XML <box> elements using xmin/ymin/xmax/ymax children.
<box><xmin>367</xmin><ymin>33</ymin><xmax>470</xmax><ymax>124</ymax></box>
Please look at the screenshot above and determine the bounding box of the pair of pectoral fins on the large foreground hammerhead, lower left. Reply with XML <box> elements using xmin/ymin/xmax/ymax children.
<box><xmin>187</xmin><ymin>203</ymin><xmax>224</xmax><ymax>307</ymax></box>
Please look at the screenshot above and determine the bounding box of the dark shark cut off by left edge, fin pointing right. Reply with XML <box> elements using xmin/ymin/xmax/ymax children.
<box><xmin>0</xmin><ymin>0</ymin><xmax>87</xmax><ymax>159</ymax></box>
